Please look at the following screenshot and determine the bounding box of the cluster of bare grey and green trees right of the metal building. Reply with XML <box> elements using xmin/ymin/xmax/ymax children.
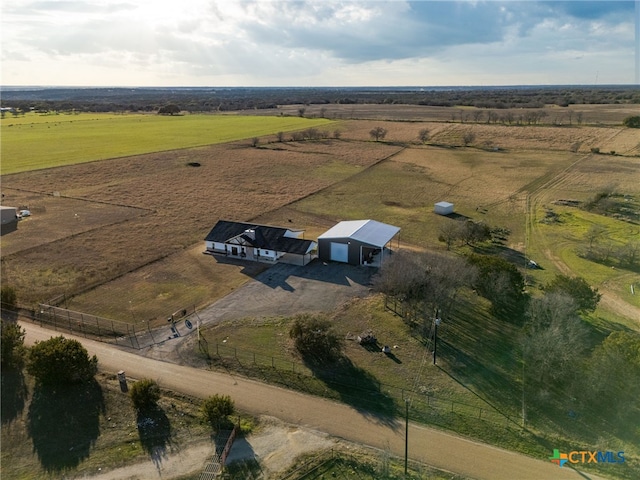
<box><xmin>373</xmin><ymin>251</ymin><xmax>640</xmax><ymax>428</ymax></box>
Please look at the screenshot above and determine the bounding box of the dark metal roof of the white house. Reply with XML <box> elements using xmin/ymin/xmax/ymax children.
<box><xmin>205</xmin><ymin>220</ymin><xmax>315</xmax><ymax>255</ymax></box>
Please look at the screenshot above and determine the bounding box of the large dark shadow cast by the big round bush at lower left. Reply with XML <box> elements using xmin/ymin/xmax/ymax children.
<box><xmin>27</xmin><ymin>379</ymin><xmax>105</xmax><ymax>472</ymax></box>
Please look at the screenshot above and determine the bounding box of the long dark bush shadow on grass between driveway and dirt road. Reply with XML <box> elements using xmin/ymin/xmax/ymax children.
<box><xmin>304</xmin><ymin>356</ymin><xmax>397</xmax><ymax>426</ymax></box>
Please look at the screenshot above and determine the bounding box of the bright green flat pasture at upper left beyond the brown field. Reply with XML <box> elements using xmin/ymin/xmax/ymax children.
<box><xmin>0</xmin><ymin>114</ymin><xmax>331</xmax><ymax>175</ymax></box>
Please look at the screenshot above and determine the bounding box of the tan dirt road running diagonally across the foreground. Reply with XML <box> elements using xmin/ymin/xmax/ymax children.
<box><xmin>23</xmin><ymin>323</ymin><xmax>598</xmax><ymax>480</ymax></box>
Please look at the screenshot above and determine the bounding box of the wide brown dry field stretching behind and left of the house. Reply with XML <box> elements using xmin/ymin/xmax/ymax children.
<box><xmin>1</xmin><ymin>110</ymin><xmax>640</xmax><ymax>322</ymax></box>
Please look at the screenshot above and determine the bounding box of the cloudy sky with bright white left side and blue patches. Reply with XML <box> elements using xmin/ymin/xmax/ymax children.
<box><xmin>0</xmin><ymin>0</ymin><xmax>640</xmax><ymax>86</ymax></box>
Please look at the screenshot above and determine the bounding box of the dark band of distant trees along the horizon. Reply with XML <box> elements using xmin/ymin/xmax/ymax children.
<box><xmin>2</xmin><ymin>85</ymin><xmax>640</xmax><ymax>112</ymax></box>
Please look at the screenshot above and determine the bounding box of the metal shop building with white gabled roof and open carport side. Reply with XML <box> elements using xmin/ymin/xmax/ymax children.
<box><xmin>318</xmin><ymin>220</ymin><xmax>400</xmax><ymax>267</ymax></box>
